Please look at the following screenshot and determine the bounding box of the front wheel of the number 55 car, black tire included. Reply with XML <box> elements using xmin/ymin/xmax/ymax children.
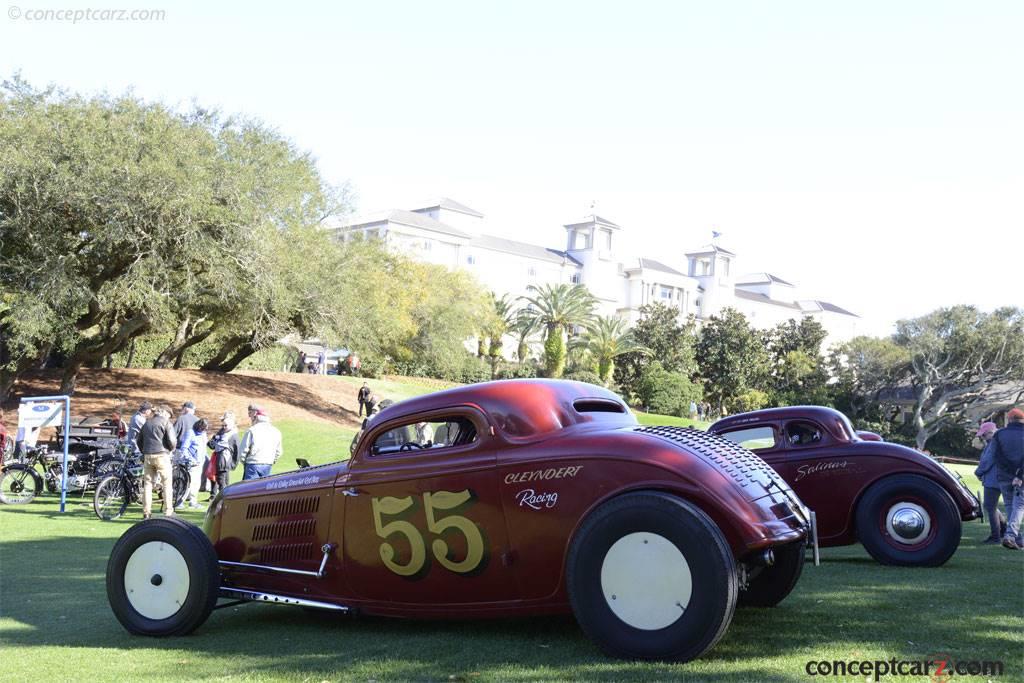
<box><xmin>106</xmin><ymin>517</ymin><xmax>220</xmax><ymax>636</ymax></box>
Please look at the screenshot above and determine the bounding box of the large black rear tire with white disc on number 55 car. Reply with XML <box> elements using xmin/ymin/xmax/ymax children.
<box><xmin>566</xmin><ymin>493</ymin><xmax>738</xmax><ymax>661</ymax></box>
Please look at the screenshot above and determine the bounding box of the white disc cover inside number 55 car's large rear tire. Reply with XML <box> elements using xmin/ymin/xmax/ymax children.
<box><xmin>601</xmin><ymin>531</ymin><xmax>693</xmax><ymax>631</ymax></box>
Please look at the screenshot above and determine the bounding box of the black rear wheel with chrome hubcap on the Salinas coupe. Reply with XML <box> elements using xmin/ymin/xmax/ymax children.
<box><xmin>856</xmin><ymin>474</ymin><xmax>961</xmax><ymax>567</ymax></box>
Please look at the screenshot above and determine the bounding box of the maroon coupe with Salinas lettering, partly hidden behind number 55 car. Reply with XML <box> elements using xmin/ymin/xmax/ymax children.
<box><xmin>709</xmin><ymin>405</ymin><xmax>979</xmax><ymax>566</ymax></box>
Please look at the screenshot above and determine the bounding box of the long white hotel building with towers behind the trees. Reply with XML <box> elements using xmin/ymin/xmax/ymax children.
<box><xmin>338</xmin><ymin>198</ymin><xmax>860</xmax><ymax>345</ymax></box>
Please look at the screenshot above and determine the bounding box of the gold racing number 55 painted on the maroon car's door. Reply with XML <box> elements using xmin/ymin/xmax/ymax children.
<box><xmin>371</xmin><ymin>488</ymin><xmax>483</xmax><ymax>577</ymax></box>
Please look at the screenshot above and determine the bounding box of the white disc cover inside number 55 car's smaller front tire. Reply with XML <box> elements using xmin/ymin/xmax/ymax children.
<box><xmin>124</xmin><ymin>541</ymin><xmax>189</xmax><ymax>620</ymax></box>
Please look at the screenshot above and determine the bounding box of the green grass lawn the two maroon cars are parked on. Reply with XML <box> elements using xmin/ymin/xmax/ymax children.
<box><xmin>0</xmin><ymin>444</ymin><xmax>1024</xmax><ymax>683</ymax></box>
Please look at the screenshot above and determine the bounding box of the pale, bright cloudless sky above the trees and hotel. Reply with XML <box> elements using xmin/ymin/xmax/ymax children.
<box><xmin>0</xmin><ymin>0</ymin><xmax>1024</xmax><ymax>332</ymax></box>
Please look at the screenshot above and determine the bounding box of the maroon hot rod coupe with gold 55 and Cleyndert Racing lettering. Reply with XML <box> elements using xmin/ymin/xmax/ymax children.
<box><xmin>106</xmin><ymin>380</ymin><xmax>809</xmax><ymax>660</ymax></box>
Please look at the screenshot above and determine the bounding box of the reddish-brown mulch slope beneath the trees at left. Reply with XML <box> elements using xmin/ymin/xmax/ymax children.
<box><xmin>4</xmin><ymin>370</ymin><xmax>368</xmax><ymax>428</ymax></box>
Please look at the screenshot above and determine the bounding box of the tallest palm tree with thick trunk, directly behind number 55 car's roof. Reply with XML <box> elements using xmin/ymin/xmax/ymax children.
<box><xmin>522</xmin><ymin>284</ymin><xmax>597</xmax><ymax>378</ymax></box>
